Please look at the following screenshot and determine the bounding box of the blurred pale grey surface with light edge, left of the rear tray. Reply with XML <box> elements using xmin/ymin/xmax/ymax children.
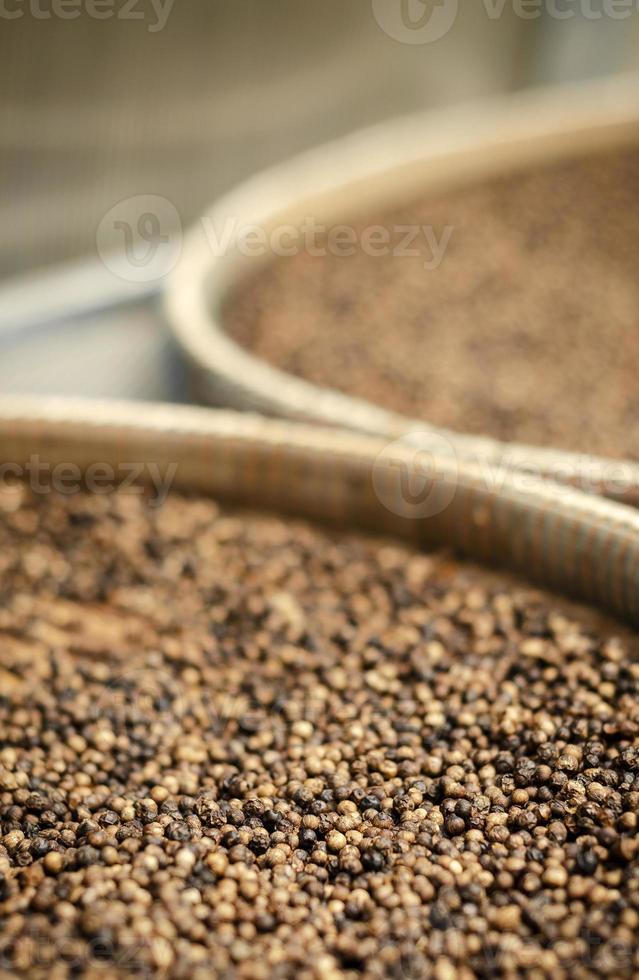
<box><xmin>0</xmin><ymin>261</ymin><xmax>185</xmax><ymax>401</ymax></box>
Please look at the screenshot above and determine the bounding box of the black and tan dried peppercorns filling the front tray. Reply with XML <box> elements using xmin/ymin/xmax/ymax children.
<box><xmin>0</xmin><ymin>491</ymin><xmax>639</xmax><ymax>980</ymax></box>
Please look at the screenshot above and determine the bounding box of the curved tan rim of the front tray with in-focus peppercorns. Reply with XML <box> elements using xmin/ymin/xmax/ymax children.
<box><xmin>0</xmin><ymin>397</ymin><xmax>639</xmax><ymax>625</ymax></box>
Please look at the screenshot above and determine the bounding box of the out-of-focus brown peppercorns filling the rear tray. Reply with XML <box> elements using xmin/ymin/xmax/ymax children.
<box><xmin>224</xmin><ymin>149</ymin><xmax>639</xmax><ymax>459</ymax></box>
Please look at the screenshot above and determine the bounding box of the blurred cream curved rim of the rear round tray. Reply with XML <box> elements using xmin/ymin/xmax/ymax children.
<box><xmin>166</xmin><ymin>74</ymin><xmax>639</xmax><ymax>505</ymax></box>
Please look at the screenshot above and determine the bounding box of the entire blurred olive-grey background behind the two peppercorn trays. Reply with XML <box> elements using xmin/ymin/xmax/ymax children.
<box><xmin>0</xmin><ymin>0</ymin><xmax>639</xmax><ymax>397</ymax></box>
